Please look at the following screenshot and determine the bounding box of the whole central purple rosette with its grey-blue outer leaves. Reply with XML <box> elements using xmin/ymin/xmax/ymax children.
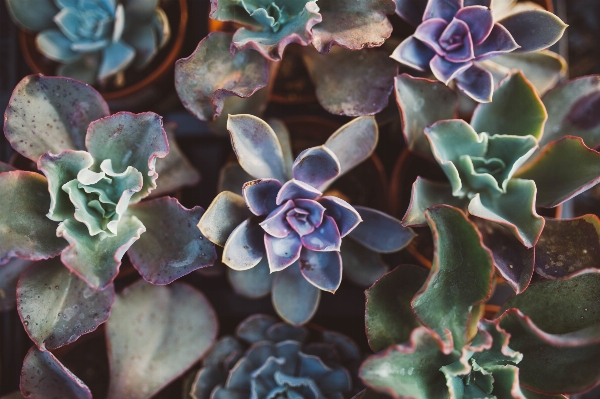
<box><xmin>198</xmin><ymin>115</ymin><xmax>413</xmax><ymax>324</ymax></box>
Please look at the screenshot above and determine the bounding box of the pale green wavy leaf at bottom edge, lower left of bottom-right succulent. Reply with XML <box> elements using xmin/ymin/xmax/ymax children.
<box><xmin>359</xmin><ymin>327</ymin><xmax>460</xmax><ymax>399</ymax></box>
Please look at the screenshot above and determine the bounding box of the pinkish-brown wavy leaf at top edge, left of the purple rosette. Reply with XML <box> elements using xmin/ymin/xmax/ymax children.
<box><xmin>312</xmin><ymin>0</ymin><xmax>395</xmax><ymax>54</ymax></box>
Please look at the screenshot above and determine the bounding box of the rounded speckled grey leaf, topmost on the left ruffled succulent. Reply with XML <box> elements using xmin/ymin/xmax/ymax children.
<box><xmin>4</xmin><ymin>75</ymin><xmax>109</xmax><ymax>162</ymax></box>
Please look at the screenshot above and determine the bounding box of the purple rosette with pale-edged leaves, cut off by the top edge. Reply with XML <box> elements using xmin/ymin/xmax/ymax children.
<box><xmin>392</xmin><ymin>0</ymin><xmax>566</xmax><ymax>102</ymax></box>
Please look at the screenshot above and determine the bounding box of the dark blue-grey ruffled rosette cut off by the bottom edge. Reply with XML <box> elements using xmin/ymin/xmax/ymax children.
<box><xmin>189</xmin><ymin>314</ymin><xmax>361</xmax><ymax>399</ymax></box>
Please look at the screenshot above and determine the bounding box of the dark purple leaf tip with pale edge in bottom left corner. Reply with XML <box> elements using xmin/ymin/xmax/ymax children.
<box><xmin>20</xmin><ymin>346</ymin><xmax>92</xmax><ymax>399</ymax></box>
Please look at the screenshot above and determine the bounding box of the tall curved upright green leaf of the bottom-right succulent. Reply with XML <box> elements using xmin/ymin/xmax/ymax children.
<box><xmin>412</xmin><ymin>205</ymin><xmax>494</xmax><ymax>348</ymax></box>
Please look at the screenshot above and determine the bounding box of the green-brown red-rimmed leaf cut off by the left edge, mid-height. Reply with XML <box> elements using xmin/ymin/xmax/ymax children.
<box><xmin>0</xmin><ymin>171</ymin><xmax>67</xmax><ymax>267</ymax></box>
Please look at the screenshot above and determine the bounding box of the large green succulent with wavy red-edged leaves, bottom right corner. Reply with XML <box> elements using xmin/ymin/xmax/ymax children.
<box><xmin>360</xmin><ymin>205</ymin><xmax>600</xmax><ymax>399</ymax></box>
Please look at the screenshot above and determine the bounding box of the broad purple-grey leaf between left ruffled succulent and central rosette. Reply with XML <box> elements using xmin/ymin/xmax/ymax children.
<box><xmin>128</xmin><ymin>197</ymin><xmax>217</xmax><ymax>285</ymax></box>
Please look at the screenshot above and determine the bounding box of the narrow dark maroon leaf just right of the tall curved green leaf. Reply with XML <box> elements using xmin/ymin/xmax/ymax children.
<box><xmin>473</xmin><ymin>218</ymin><xmax>536</xmax><ymax>294</ymax></box>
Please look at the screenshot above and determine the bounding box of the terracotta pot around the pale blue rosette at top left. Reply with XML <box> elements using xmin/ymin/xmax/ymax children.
<box><xmin>19</xmin><ymin>0</ymin><xmax>188</xmax><ymax>111</ymax></box>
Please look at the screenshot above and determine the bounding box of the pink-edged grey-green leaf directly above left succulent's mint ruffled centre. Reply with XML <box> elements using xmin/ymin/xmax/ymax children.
<box><xmin>85</xmin><ymin>112</ymin><xmax>169</xmax><ymax>203</ymax></box>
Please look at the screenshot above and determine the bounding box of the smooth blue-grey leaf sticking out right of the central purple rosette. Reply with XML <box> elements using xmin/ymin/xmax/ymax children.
<box><xmin>350</xmin><ymin>206</ymin><xmax>415</xmax><ymax>253</ymax></box>
